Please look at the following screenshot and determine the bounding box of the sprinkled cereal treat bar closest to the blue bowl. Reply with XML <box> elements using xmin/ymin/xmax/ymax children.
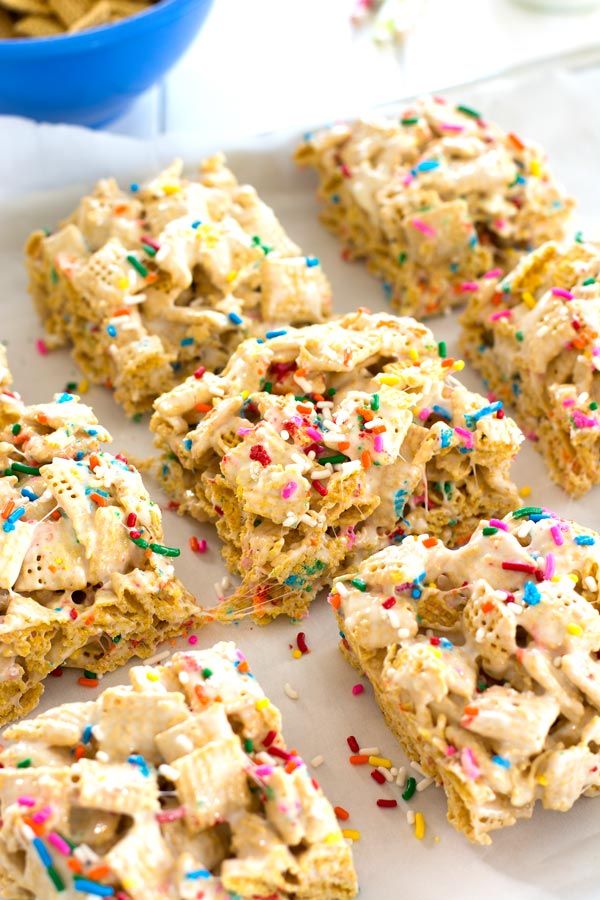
<box><xmin>26</xmin><ymin>156</ymin><xmax>331</xmax><ymax>413</ymax></box>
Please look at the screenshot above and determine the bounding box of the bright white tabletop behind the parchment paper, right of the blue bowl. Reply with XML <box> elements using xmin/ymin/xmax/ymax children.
<box><xmin>111</xmin><ymin>0</ymin><xmax>600</xmax><ymax>145</ymax></box>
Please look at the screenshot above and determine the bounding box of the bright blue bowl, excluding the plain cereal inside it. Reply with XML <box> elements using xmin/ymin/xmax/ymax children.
<box><xmin>0</xmin><ymin>0</ymin><xmax>213</xmax><ymax>127</ymax></box>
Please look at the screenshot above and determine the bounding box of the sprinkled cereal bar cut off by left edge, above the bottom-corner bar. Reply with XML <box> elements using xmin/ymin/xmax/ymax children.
<box><xmin>0</xmin><ymin>378</ymin><xmax>199</xmax><ymax>724</ymax></box>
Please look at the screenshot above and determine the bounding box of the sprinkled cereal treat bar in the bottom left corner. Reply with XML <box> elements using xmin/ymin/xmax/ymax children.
<box><xmin>0</xmin><ymin>643</ymin><xmax>357</xmax><ymax>900</ymax></box>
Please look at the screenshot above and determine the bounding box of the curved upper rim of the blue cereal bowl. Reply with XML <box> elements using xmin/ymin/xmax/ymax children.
<box><xmin>0</xmin><ymin>0</ymin><xmax>213</xmax><ymax>52</ymax></box>
